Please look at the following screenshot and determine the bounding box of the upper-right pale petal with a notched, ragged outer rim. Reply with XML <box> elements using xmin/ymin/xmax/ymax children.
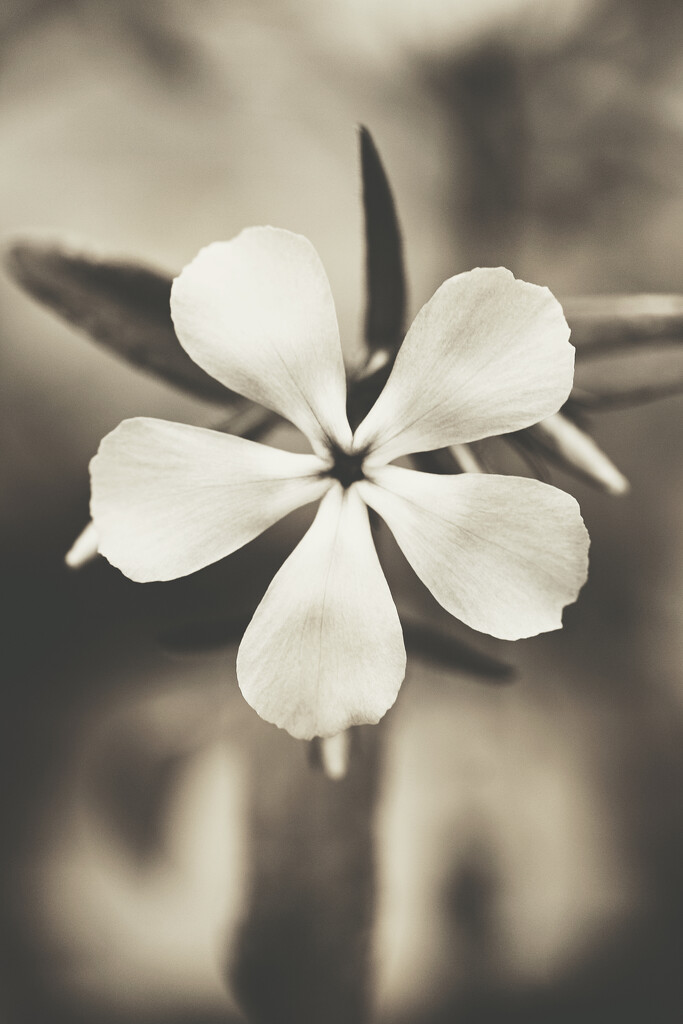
<box><xmin>353</xmin><ymin>267</ymin><xmax>574</xmax><ymax>465</ymax></box>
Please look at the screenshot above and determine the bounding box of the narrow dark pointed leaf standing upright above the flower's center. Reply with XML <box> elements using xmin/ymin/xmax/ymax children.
<box><xmin>360</xmin><ymin>125</ymin><xmax>405</xmax><ymax>352</ymax></box>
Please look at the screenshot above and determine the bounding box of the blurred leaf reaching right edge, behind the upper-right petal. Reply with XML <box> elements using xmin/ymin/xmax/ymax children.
<box><xmin>562</xmin><ymin>295</ymin><xmax>683</xmax><ymax>358</ymax></box>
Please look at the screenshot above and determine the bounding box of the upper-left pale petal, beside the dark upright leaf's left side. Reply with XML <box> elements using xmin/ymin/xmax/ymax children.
<box><xmin>171</xmin><ymin>227</ymin><xmax>351</xmax><ymax>451</ymax></box>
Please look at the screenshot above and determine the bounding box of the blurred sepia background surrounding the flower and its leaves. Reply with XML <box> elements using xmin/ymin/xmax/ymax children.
<box><xmin>0</xmin><ymin>0</ymin><xmax>683</xmax><ymax>1024</ymax></box>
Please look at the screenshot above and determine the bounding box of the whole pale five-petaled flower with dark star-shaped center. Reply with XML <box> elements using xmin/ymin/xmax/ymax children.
<box><xmin>91</xmin><ymin>227</ymin><xmax>588</xmax><ymax>738</ymax></box>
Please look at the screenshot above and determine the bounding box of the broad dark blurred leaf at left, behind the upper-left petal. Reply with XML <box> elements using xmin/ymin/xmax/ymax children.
<box><xmin>5</xmin><ymin>241</ymin><xmax>237</xmax><ymax>406</ymax></box>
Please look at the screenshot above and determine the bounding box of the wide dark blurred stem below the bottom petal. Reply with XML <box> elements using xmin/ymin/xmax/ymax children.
<box><xmin>230</xmin><ymin>726</ymin><xmax>383</xmax><ymax>1024</ymax></box>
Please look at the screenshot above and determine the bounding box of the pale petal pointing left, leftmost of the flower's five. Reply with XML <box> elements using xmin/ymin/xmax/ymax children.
<box><xmin>90</xmin><ymin>418</ymin><xmax>331</xmax><ymax>583</ymax></box>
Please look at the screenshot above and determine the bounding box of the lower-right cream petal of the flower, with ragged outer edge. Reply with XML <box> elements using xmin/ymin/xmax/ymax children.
<box><xmin>357</xmin><ymin>466</ymin><xmax>589</xmax><ymax>640</ymax></box>
